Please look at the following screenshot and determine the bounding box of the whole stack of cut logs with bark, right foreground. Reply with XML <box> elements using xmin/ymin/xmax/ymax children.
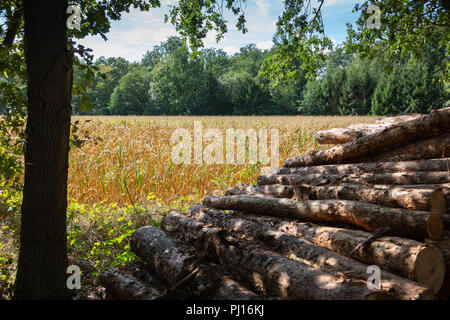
<box><xmin>100</xmin><ymin>108</ymin><xmax>450</xmax><ymax>300</ymax></box>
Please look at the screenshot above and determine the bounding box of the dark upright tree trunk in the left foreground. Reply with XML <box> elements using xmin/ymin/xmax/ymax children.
<box><xmin>15</xmin><ymin>0</ymin><xmax>72</xmax><ymax>299</ymax></box>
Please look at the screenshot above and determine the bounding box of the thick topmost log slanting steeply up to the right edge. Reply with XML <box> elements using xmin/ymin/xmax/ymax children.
<box><xmin>283</xmin><ymin>108</ymin><xmax>450</xmax><ymax>167</ymax></box>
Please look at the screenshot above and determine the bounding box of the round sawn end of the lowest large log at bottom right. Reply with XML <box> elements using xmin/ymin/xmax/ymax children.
<box><xmin>414</xmin><ymin>246</ymin><xmax>445</xmax><ymax>293</ymax></box>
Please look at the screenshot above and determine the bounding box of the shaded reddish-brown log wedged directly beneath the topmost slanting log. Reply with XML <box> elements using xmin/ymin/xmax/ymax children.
<box><xmin>357</xmin><ymin>133</ymin><xmax>450</xmax><ymax>162</ymax></box>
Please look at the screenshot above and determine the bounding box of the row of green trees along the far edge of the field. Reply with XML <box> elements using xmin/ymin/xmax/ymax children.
<box><xmin>73</xmin><ymin>33</ymin><xmax>449</xmax><ymax>115</ymax></box>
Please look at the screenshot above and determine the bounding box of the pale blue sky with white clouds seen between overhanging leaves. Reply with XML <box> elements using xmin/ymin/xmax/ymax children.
<box><xmin>80</xmin><ymin>0</ymin><xmax>360</xmax><ymax>61</ymax></box>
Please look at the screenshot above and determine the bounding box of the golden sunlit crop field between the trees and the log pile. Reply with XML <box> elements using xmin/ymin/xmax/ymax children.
<box><xmin>68</xmin><ymin>116</ymin><xmax>375</xmax><ymax>204</ymax></box>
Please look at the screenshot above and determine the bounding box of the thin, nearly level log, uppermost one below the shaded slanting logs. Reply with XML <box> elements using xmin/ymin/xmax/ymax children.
<box><xmin>273</xmin><ymin>158</ymin><xmax>450</xmax><ymax>175</ymax></box>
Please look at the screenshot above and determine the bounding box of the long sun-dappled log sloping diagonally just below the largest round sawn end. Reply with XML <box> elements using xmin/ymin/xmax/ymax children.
<box><xmin>174</xmin><ymin>205</ymin><xmax>434</xmax><ymax>300</ymax></box>
